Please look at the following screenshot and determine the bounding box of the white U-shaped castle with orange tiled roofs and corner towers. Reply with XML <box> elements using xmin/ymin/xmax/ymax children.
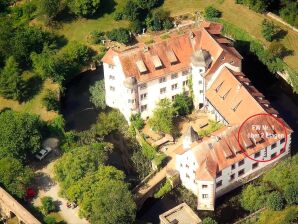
<box><xmin>102</xmin><ymin>22</ymin><xmax>292</xmax><ymax>210</ymax></box>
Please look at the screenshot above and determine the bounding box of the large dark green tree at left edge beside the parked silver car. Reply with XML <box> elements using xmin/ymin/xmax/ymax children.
<box><xmin>0</xmin><ymin>110</ymin><xmax>41</xmax><ymax>161</ymax></box>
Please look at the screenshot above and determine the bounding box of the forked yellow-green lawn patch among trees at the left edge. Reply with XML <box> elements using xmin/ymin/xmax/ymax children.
<box><xmin>0</xmin><ymin>80</ymin><xmax>59</xmax><ymax>121</ymax></box>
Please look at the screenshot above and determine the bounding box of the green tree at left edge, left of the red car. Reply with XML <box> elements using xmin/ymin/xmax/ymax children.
<box><xmin>0</xmin><ymin>156</ymin><xmax>33</xmax><ymax>198</ymax></box>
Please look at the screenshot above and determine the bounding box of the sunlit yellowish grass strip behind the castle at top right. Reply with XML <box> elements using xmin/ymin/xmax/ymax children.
<box><xmin>162</xmin><ymin>0</ymin><xmax>298</xmax><ymax>71</ymax></box>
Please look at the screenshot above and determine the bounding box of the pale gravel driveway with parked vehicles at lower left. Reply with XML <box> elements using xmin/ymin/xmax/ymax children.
<box><xmin>33</xmin><ymin>138</ymin><xmax>89</xmax><ymax>224</ymax></box>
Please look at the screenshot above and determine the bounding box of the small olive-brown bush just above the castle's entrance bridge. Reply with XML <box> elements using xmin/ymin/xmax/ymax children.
<box><xmin>131</xmin><ymin>150</ymin><xmax>151</xmax><ymax>180</ymax></box>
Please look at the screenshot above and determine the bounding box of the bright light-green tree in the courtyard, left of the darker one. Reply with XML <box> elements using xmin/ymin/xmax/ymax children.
<box><xmin>149</xmin><ymin>99</ymin><xmax>176</xmax><ymax>134</ymax></box>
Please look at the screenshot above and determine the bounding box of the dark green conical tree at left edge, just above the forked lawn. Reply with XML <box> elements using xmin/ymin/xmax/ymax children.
<box><xmin>0</xmin><ymin>57</ymin><xmax>25</xmax><ymax>101</ymax></box>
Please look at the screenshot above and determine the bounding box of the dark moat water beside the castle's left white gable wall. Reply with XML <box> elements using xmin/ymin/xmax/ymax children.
<box><xmin>61</xmin><ymin>67</ymin><xmax>103</xmax><ymax>131</ymax></box>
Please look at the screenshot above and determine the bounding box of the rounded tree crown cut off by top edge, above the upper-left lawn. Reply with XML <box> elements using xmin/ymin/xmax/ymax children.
<box><xmin>68</xmin><ymin>0</ymin><xmax>100</xmax><ymax>17</ymax></box>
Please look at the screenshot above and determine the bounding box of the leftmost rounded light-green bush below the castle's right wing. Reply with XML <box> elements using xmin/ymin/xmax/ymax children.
<box><xmin>240</xmin><ymin>184</ymin><xmax>270</xmax><ymax>212</ymax></box>
